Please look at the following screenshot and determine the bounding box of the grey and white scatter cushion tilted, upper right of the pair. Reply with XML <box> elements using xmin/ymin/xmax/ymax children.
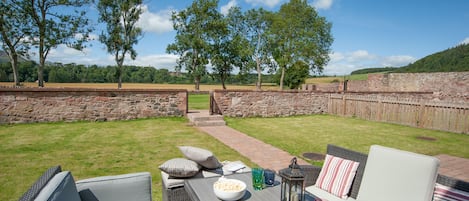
<box><xmin>179</xmin><ymin>146</ymin><xmax>222</xmax><ymax>169</ymax></box>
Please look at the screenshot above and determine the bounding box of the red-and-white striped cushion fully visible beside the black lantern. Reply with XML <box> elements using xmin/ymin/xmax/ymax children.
<box><xmin>315</xmin><ymin>155</ymin><xmax>359</xmax><ymax>199</ymax></box>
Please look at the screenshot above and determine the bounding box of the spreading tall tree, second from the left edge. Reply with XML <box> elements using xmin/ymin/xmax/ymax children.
<box><xmin>23</xmin><ymin>0</ymin><xmax>92</xmax><ymax>87</ymax></box>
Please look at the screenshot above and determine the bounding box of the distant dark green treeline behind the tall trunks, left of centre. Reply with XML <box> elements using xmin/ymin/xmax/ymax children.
<box><xmin>0</xmin><ymin>61</ymin><xmax>275</xmax><ymax>84</ymax></box>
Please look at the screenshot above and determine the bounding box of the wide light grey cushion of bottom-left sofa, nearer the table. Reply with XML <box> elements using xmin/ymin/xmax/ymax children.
<box><xmin>76</xmin><ymin>172</ymin><xmax>152</xmax><ymax>201</ymax></box>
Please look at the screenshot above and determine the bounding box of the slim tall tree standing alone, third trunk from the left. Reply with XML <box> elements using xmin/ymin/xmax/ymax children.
<box><xmin>98</xmin><ymin>0</ymin><xmax>143</xmax><ymax>89</ymax></box>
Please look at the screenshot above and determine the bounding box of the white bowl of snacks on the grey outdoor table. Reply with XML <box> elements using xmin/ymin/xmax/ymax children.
<box><xmin>213</xmin><ymin>177</ymin><xmax>246</xmax><ymax>201</ymax></box>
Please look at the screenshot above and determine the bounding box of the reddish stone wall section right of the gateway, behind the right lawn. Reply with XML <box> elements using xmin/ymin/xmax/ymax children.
<box><xmin>213</xmin><ymin>90</ymin><xmax>329</xmax><ymax>117</ymax></box>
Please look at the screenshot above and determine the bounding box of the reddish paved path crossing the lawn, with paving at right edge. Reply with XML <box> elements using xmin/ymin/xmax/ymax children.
<box><xmin>189</xmin><ymin>111</ymin><xmax>469</xmax><ymax>182</ymax></box>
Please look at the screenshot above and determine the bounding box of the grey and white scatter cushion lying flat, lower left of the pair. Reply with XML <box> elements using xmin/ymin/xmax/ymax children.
<box><xmin>159</xmin><ymin>158</ymin><xmax>200</xmax><ymax>178</ymax></box>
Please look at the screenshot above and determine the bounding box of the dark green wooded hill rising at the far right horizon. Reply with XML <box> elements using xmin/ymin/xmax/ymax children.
<box><xmin>351</xmin><ymin>44</ymin><xmax>469</xmax><ymax>74</ymax></box>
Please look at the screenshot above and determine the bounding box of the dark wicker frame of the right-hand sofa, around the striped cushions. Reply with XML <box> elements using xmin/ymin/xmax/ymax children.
<box><xmin>301</xmin><ymin>144</ymin><xmax>469</xmax><ymax>200</ymax></box>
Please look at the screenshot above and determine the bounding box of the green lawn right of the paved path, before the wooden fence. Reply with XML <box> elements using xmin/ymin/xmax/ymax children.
<box><xmin>226</xmin><ymin>115</ymin><xmax>469</xmax><ymax>158</ymax></box>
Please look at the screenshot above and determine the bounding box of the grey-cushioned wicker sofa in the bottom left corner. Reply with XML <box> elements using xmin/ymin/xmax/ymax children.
<box><xmin>19</xmin><ymin>166</ymin><xmax>152</xmax><ymax>201</ymax></box>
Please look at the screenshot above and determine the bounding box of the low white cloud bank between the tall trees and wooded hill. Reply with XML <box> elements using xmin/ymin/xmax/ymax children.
<box><xmin>323</xmin><ymin>50</ymin><xmax>416</xmax><ymax>75</ymax></box>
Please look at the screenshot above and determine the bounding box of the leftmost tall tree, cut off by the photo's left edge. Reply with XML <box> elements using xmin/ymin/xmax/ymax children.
<box><xmin>0</xmin><ymin>0</ymin><xmax>31</xmax><ymax>86</ymax></box>
